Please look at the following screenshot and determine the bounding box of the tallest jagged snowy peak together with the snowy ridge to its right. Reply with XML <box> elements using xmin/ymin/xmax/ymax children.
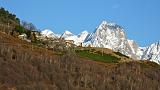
<box><xmin>84</xmin><ymin>21</ymin><xmax>160</xmax><ymax>64</ymax></box>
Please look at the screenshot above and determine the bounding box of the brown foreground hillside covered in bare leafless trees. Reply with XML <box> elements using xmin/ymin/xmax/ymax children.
<box><xmin>0</xmin><ymin>32</ymin><xmax>160</xmax><ymax>90</ymax></box>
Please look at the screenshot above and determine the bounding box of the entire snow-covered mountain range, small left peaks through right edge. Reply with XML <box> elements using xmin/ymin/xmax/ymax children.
<box><xmin>41</xmin><ymin>21</ymin><xmax>160</xmax><ymax>64</ymax></box>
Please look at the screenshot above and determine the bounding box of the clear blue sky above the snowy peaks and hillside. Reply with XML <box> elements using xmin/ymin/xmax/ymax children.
<box><xmin>0</xmin><ymin>0</ymin><xmax>160</xmax><ymax>46</ymax></box>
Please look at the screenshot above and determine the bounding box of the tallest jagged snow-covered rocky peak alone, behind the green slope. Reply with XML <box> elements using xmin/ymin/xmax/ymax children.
<box><xmin>84</xmin><ymin>21</ymin><xmax>137</xmax><ymax>59</ymax></box>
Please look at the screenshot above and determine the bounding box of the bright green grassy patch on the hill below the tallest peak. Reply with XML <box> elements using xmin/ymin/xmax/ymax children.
<box><xmin>75</xmin><ymin>47</ymin><xmax>131</xmax><ymax>63</ymax></box>
